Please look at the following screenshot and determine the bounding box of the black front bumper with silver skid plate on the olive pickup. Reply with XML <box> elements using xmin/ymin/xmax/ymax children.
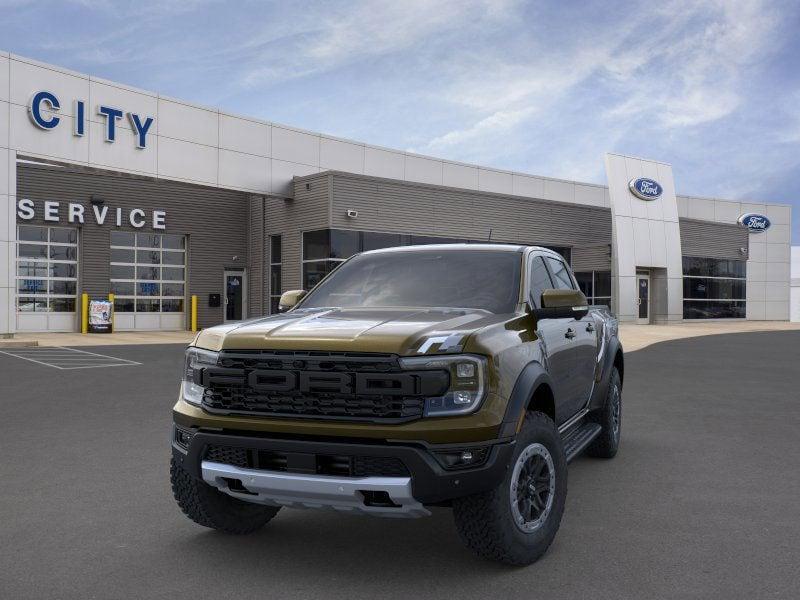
<box><xmin>172</xmin><ymin>429</ymin><xmax>513</xmax><ymax>517</ymax></box>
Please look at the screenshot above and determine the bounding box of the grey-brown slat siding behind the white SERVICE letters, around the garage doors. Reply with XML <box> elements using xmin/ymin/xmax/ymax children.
<box><xmin>17</xmin><ymin>164</ymin><xmax>248</xmax><ymax>327</ymax></box>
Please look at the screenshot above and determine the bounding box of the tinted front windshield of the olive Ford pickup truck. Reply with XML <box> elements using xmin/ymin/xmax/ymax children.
<box><xmin>302</xmin><ymin>250</ymin><xmax>522</xmax><ymax>313</ymax></box>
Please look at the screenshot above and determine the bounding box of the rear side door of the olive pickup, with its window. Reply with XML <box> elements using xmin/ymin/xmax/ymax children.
<box><xmin>545</xmin><ymin>256</ymin><xmax>597</xmax><ymax>420</ymax></box>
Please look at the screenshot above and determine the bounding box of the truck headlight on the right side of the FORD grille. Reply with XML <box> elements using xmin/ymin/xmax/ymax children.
<box><xmin>400</xmin><ymin>354</ymin><xmax>486</xmax><ymax>417</ymax></box>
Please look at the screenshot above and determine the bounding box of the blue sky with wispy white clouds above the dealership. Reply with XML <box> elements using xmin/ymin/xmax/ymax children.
<box><xmin>0</xmin><ymin>0</ymin><xmax>800</xmax><ymax>244</ymax></box>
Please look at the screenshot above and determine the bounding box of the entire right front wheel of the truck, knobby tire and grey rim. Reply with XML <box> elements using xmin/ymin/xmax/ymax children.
<box><xmin>453</xmin><ymin>412</ymin><xmax>567</xmax><ymax>565</ymax></box>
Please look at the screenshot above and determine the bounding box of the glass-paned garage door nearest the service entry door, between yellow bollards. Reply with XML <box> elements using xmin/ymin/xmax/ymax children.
<box><xmin>109</xmin><ymin>231</ymin><xmax>186</xmax><ymax>331</ymax></box>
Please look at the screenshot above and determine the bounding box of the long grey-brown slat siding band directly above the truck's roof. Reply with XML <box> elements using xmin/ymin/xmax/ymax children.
<box><xmin>331</xmin><ymin>173</ymin><xmax>611</xmax><ymax>247</ymax></box>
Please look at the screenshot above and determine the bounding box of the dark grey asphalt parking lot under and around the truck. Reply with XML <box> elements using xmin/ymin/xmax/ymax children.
<box><xmin>0</xmin><ymin>331</ymin><xmax>800</xmax><ymax>600</ymax></box>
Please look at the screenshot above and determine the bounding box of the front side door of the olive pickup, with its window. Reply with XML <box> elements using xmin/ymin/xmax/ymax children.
<box><xmin>528</xmin><ymin>256</ymin><xmax>575</xmax><ymax>425</ymax></box>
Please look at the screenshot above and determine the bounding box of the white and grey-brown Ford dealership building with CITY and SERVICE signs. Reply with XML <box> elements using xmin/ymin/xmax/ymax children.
<box><xmin>0</xmin><ymin>53</ymin><xmax>791</xmax><ymax>336</ymax></box>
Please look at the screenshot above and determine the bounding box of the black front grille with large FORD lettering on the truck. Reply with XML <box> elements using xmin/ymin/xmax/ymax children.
<box><xmin>201</xmin><ymin>351</ymin><xmax>449</xmax><ymax>422</ymax></box>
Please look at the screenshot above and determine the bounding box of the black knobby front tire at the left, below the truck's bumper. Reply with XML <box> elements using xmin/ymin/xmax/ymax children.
<box><xmin>169</xmin><ymin>458</ymin><xmax>280</xmax><ymax>535</ymax></box>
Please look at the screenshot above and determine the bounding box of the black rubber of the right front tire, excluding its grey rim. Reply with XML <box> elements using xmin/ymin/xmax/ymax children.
<box><xmin>453</xmin><ymin>412</ymin><xmax>567</xmax><ymax>565</ymax></box>
